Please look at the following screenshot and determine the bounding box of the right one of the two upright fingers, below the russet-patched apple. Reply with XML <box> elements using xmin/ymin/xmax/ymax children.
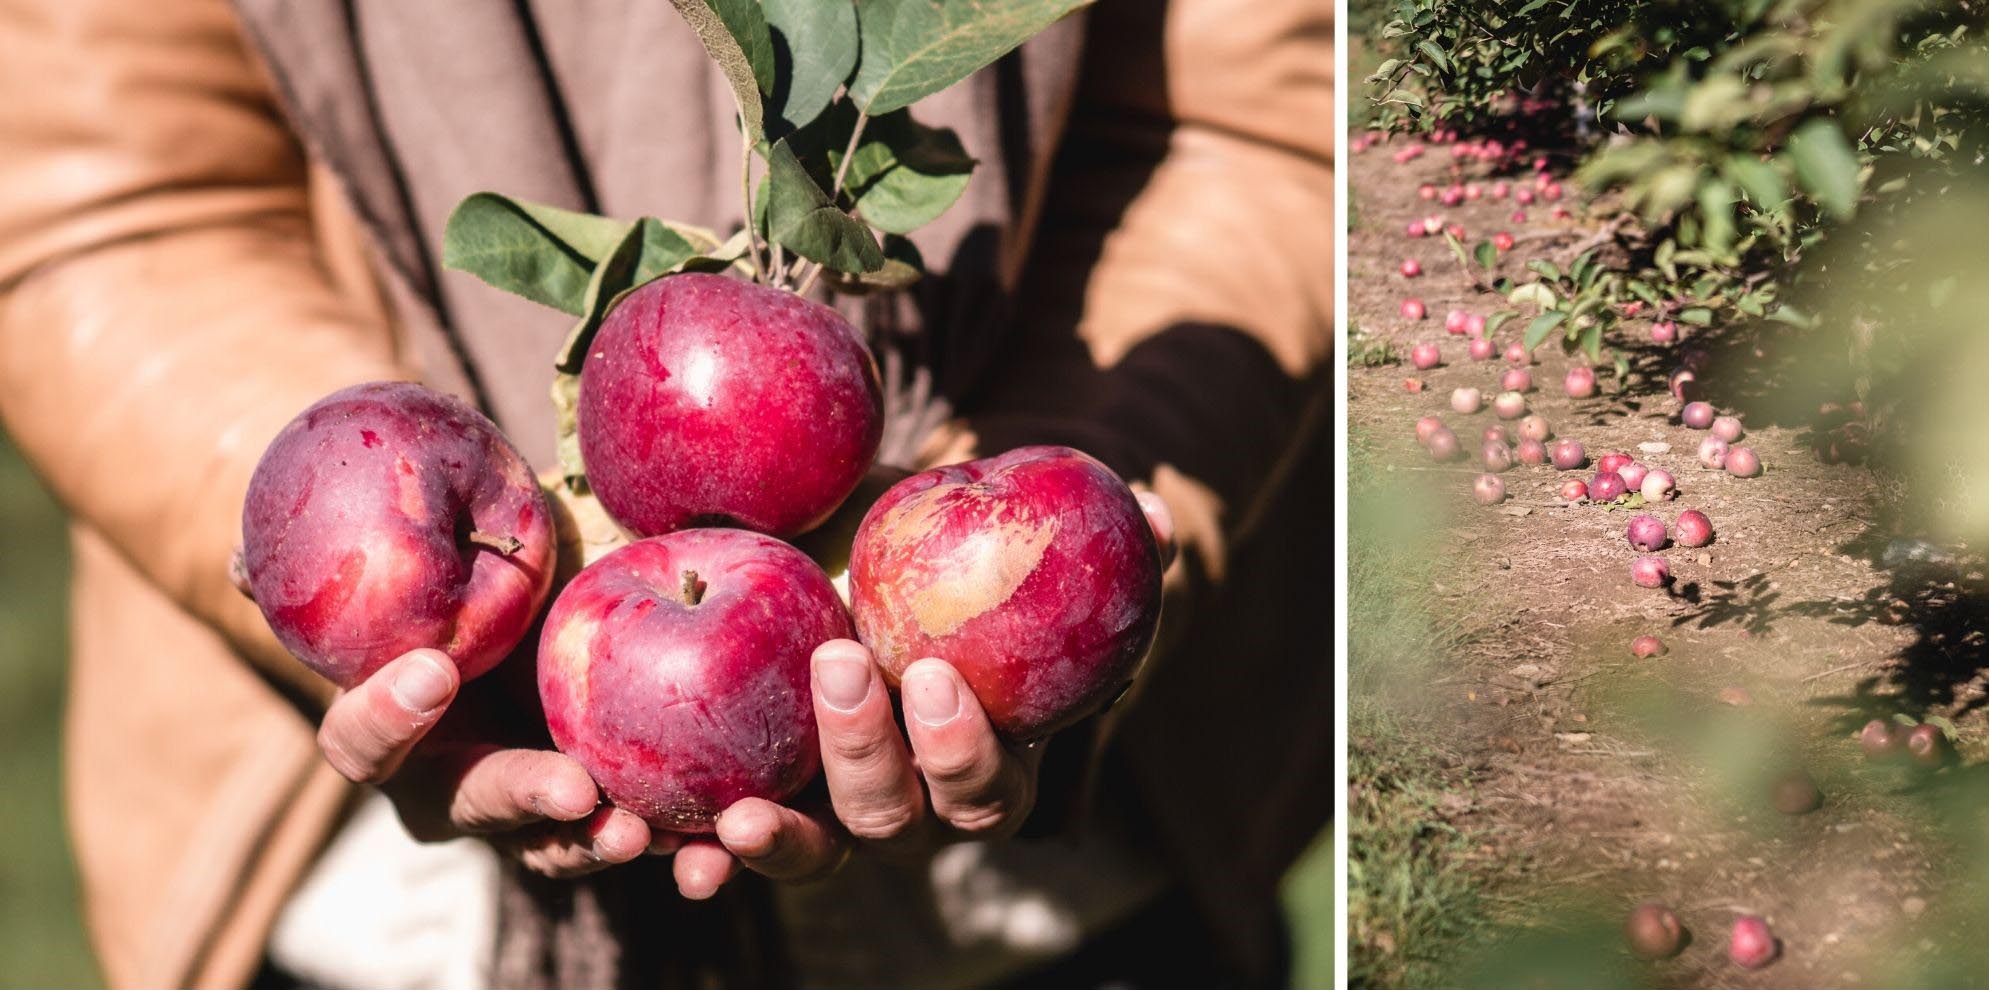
<box><xmin>899</xmin><ymin>658</ymin><xmax>1036</xmax><ymax>835</ymax></box>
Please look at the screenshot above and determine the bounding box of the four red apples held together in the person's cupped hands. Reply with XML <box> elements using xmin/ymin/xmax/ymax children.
<box><xmin>239</xmin><ymin>272</ymin><xmax>1162</xmax><ymax>833</ymax></box>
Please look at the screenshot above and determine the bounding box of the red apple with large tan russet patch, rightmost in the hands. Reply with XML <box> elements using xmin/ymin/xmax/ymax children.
<box><xmin>849</xmin><ymin>447</ymin><xmax>1162</xmax><ymax>740</ymax></box>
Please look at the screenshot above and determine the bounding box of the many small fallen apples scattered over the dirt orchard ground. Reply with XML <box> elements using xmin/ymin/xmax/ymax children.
<box><xmin>1355</xmin><ymin>121</ymin><xmax>1953</xmax><ymax>968</ymax></box>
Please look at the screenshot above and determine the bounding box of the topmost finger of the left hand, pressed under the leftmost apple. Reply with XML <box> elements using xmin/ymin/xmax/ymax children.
<box><xmin>318</xmin><ymin>650</ymin><xmax>461</xmax><ymax>783</ymax></box>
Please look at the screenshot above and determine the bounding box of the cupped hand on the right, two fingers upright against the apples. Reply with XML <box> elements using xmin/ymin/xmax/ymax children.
<box><xmin>674</xmin><ymin>491</ymin><xmax>1174</xmax><ymax>899</ymax></box>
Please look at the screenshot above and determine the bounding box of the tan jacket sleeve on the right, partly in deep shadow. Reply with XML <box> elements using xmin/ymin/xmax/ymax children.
<box><xmin>929</xmin><ymin>0</ymin><xmax>1335</xmax><ymax>588</ymax></box>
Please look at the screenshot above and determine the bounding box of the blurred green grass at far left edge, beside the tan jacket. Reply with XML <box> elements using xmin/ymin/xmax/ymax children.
<box><xmin>0</xmin><ymin>433</ymin><xmax>99</xmax><ymax>988</ymax></box>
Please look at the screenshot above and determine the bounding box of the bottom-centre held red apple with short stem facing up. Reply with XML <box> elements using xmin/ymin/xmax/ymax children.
<box><xmin>539</xmin><ymin>529</ymin><xmax>855</xmax><ymax>833</ymax></box>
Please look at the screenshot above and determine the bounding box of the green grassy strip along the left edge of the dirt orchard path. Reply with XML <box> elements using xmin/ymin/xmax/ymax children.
<box><xmin>1347</xmin><ymin>431</ymin><xmax>1486</xmax><ymax>988</ymax></box>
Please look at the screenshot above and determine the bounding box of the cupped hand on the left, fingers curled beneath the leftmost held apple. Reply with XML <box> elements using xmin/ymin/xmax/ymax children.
<box><xmin>318</xmin><ymin>650</ymin><xmax>660</xmax><ymax>877</ymax></box>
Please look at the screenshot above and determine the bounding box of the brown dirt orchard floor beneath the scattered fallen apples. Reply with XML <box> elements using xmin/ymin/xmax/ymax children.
<box><xmin>1347</xmin><ymin>145</ymin><xmax>1989</xmax><ymax>990</ymax></box>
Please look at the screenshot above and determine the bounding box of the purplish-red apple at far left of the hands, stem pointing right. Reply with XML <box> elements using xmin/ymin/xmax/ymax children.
<box><xmin>241</xmin><ymin>382</ymin><xmax>553</xmax><ymax>688</ymax></box>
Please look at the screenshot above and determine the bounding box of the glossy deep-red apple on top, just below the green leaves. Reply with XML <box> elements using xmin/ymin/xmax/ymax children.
<box><xmin>579</xmin><ymin>272</ymin><xmax>883</xmax><ymax>537</ymax></box>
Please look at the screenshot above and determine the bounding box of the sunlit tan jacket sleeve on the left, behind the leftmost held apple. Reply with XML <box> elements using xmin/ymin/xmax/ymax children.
<box><xmin>0</xmin><ymin>0</ymin><xmax>404</xmax><ymax>696</ymax></box>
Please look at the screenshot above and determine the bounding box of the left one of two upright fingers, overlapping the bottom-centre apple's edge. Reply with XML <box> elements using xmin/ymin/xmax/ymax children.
<box><xmin>814</xmin><ymin>640</ymin><xmax>925</xmax><ymax>841</ymax></box>
